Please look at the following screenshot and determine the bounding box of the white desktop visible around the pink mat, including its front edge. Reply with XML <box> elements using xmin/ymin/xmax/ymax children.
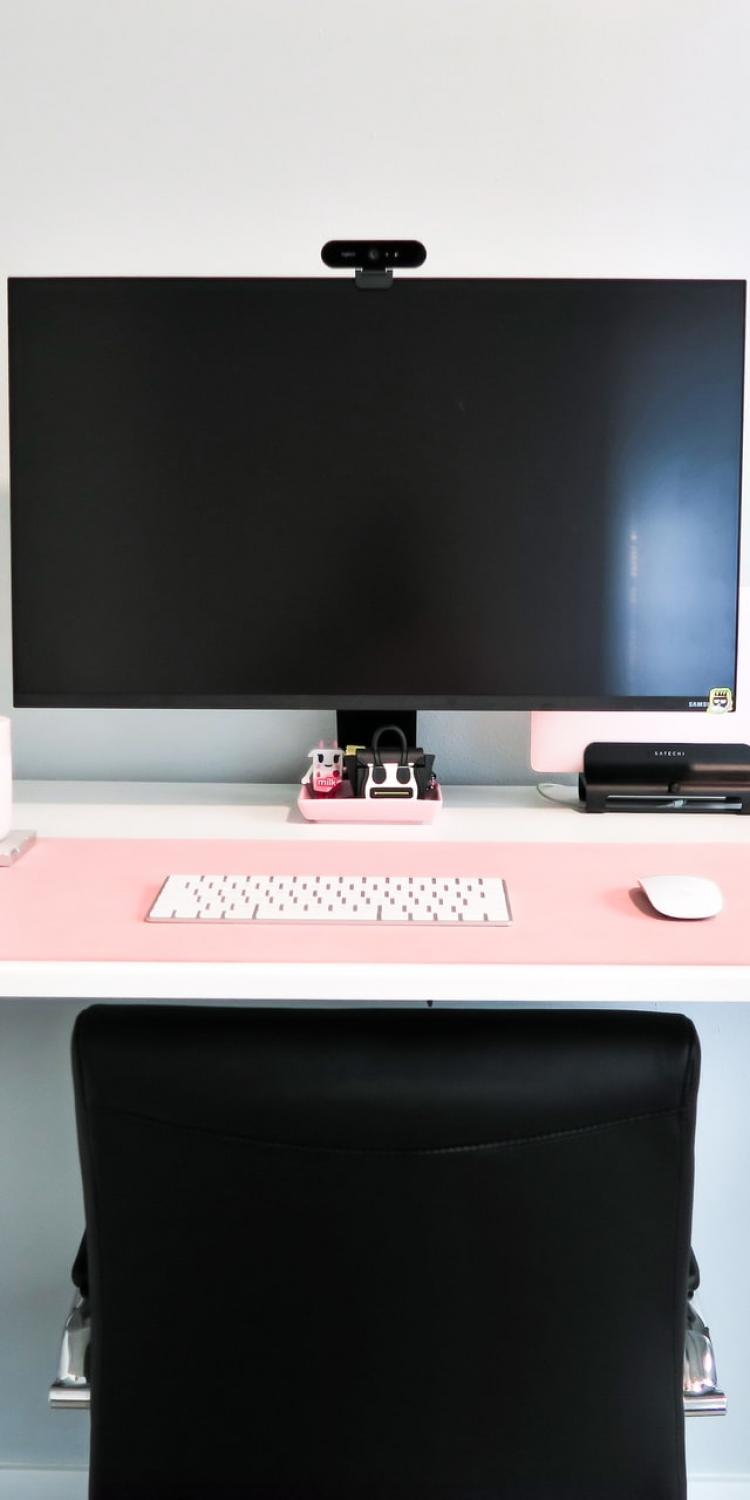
<box><xmin>0</xmin><ymin>782</ymin><xmax>750</xmax><ymax>1004</ymax></box>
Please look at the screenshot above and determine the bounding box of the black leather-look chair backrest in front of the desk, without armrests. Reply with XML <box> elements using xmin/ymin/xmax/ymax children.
<box><xmin>74</xmin><ymin>1005</ymin><xmax>699</xmax><ymax>1500</ymax></box>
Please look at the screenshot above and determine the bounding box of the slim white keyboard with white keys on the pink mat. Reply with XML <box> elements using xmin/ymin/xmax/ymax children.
<box><xmin>147</xmin><ymin>875</ymin><xmax>512</xmax><ymax>927</ymax></box>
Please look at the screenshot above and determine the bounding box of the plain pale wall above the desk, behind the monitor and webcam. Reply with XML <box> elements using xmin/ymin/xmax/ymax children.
<box><xmin>0</xmin><ymin>0</ymin><xmax>750</xmax><ymax>782</ymax></box>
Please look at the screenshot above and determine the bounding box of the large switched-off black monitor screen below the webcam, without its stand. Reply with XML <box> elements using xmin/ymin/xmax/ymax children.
<box><xmin>9</xmin><ymin>276</ymin><xmax>744</xmax><ymax>713</ymax></box>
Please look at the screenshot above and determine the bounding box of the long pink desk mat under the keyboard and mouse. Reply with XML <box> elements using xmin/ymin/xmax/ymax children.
<box><xmin>0</xmin><ymin>839</ymin><xmax>750</xmax><ymax>966</ymax></box>
